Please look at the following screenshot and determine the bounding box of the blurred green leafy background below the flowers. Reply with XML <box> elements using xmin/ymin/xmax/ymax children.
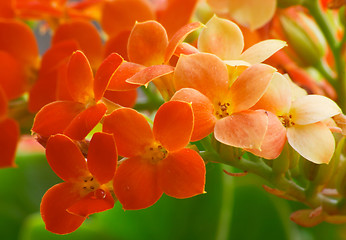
<box><xmin>0</xmin><ymin>153</ymin><xmax>346</xmax><ymax>240</ymax></box>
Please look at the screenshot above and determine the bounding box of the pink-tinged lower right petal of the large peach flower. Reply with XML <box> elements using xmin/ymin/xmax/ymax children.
<box><xmin>214</xmin><ymin>111</ymin><xmax>268</xmax><ymax>149</ymax></box>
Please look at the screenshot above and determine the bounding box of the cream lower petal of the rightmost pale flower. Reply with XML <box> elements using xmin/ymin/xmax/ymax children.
<box><xmin>287</xmin><ymin>122</ymin><xmax>335</xmax><ymax>164</ymax></box>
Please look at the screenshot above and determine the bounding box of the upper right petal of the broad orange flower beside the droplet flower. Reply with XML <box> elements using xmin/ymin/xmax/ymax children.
<box><xmin>153</xmin><ymin>101</ymin><xmax>193</xmax><ymax>151</ymax></box>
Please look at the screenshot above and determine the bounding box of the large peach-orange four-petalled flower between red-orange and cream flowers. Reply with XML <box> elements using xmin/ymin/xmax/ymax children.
<box><xmin>172</xmin><ymin>53</ymin><xmax>275</xmax><ymax>148</ymax></box>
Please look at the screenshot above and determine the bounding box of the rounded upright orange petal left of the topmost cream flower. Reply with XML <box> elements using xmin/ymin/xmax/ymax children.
<box><xmin>127</xmin><ymin>21</ymin><xmax>168</xmax><ymax>66</ymax></box>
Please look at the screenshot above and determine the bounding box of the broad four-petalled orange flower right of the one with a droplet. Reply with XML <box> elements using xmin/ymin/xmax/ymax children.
<box><xmin>103</xmin><ymin>101</ymin><xmax>205</xmax><ymax>209</ymax></box>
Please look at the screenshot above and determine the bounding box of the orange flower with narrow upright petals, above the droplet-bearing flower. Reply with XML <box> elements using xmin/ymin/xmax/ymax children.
<box><xmin>32</xmin><ymin>51</ymin><xmax>123</xmax><ymax>140</ymax></box>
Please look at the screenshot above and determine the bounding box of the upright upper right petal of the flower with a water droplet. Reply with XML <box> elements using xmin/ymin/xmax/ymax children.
<box><xmin>88</xmin><ymin>132</ymin><xmax>118</xmax><ymax>184</ymax></box>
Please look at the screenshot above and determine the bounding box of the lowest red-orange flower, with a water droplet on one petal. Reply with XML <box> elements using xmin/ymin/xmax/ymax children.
<box><xmin>41</xmin><ymin>133</ymin><xmax>117</xmax><ymax>234</ymax></box>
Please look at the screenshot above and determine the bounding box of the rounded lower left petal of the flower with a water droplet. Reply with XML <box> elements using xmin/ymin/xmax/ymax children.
<box><xmin>40</xmin><ymin>183</ymin><xmax>85</xmax><ymax>234</ymax></box>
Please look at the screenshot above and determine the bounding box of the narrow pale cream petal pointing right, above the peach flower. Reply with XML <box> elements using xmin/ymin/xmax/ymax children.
<box><xmin>239</xmin><ymin>39</ymin><xmax>287</xmax><ymax>64</ymax></box>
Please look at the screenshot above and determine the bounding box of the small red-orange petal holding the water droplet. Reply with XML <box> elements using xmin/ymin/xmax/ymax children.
<box><xmin>66</xmin><ymin>189</ymin><xmax>114</xmax><ymax>217</ymax></box>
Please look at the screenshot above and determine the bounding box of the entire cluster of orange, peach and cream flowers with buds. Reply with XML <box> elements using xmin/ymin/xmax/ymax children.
<box><xmin>0</xmin><ymin>0</ymin><xmax>346</xmax><ymax>234</ymax></box>
